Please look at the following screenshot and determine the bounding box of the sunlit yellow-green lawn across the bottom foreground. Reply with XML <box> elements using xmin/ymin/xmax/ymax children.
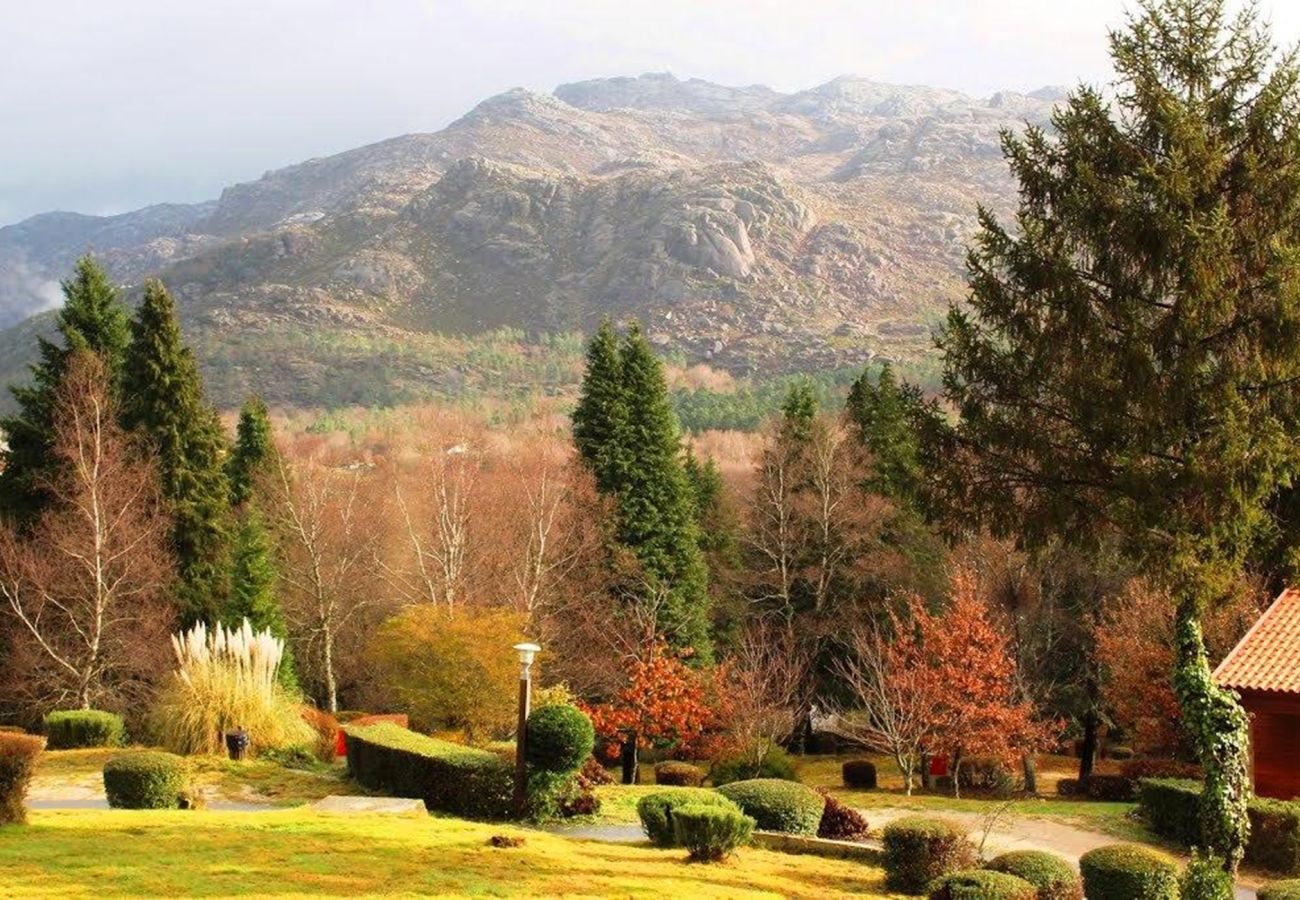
<box><xmin>0</xmin><ymin>809</ymin><xmax>889</xmax><ymax>897</ymax></box>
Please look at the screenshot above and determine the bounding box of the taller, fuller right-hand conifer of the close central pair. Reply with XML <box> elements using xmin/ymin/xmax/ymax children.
<box><xmin>616</xmin><ymin>324</ymin><xmax>712</xmax><ymax>661</ymax></box>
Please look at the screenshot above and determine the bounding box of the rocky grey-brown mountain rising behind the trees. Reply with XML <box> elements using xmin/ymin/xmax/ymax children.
<box><xmin>0</xmin><ymin>74</ymin><xmax>1062</xmax><ymax>404</ymax></box>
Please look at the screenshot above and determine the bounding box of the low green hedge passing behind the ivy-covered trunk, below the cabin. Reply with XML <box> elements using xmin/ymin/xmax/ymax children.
<box><xmin>1138</xmin><ymin>778</ymin><xmax>1300</xmax><ymax>874</ymax></box>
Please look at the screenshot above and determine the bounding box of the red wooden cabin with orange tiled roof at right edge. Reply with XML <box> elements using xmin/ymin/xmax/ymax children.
<box><xmin>1214</xmin><ymin>588</ymin><xmax>1300</xmax><ymax>800</ymax></box>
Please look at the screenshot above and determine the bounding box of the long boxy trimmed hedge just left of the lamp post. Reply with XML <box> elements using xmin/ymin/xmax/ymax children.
<box><xmin>343</xmin><ymin>723</ymin><xmax>512</xmax><ymax>819</ymax></box>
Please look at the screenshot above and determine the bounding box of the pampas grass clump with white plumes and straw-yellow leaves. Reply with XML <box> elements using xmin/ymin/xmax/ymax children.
<box><xmin>153</xmin><ymin>620</ymin><xmax>316</xmax><ymax>753</ymax></box>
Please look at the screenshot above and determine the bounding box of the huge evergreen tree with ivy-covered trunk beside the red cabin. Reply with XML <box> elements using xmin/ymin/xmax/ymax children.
<box><xmin>941</xmin><ymin>0</ymin><xmax>1300</xmax><ymax>867</ymax></box>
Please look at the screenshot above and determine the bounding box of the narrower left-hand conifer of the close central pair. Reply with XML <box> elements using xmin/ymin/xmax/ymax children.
<box><xmin>573</xmin><ymin>319</ymin><xmax>627</xmax><ymax>494</ymax></box>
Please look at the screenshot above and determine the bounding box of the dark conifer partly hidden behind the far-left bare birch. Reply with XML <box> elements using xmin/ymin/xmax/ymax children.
<box><xmin>0</xmin><ymin>255</ymin><xmax>129</xmax><ymax>524</ymax></box>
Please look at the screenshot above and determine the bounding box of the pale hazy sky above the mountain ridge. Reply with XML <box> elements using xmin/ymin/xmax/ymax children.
<box><xmin>0</xmin><ymin>0</ymin><xmax>1300</xmax><ymax>224</ymax></box>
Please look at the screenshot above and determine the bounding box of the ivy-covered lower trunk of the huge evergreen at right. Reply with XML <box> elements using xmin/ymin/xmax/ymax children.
<box><xmin>1174</xmin><ymin>598</ymin><xmax>1251</xmax><ymax>873</ymax></box>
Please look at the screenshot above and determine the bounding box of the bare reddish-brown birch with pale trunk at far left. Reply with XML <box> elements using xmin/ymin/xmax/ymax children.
<box><xmin>0</xmin><ymin>354</ymin><xmax>174</xmax><ymax>709</ymax></box>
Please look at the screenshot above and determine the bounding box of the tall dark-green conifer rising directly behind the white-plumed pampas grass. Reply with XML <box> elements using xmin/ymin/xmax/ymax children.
<box><xmin>122</xmin><ymin>281</ymin><xmax>229</xmax><ymax>624</ymax></box>
